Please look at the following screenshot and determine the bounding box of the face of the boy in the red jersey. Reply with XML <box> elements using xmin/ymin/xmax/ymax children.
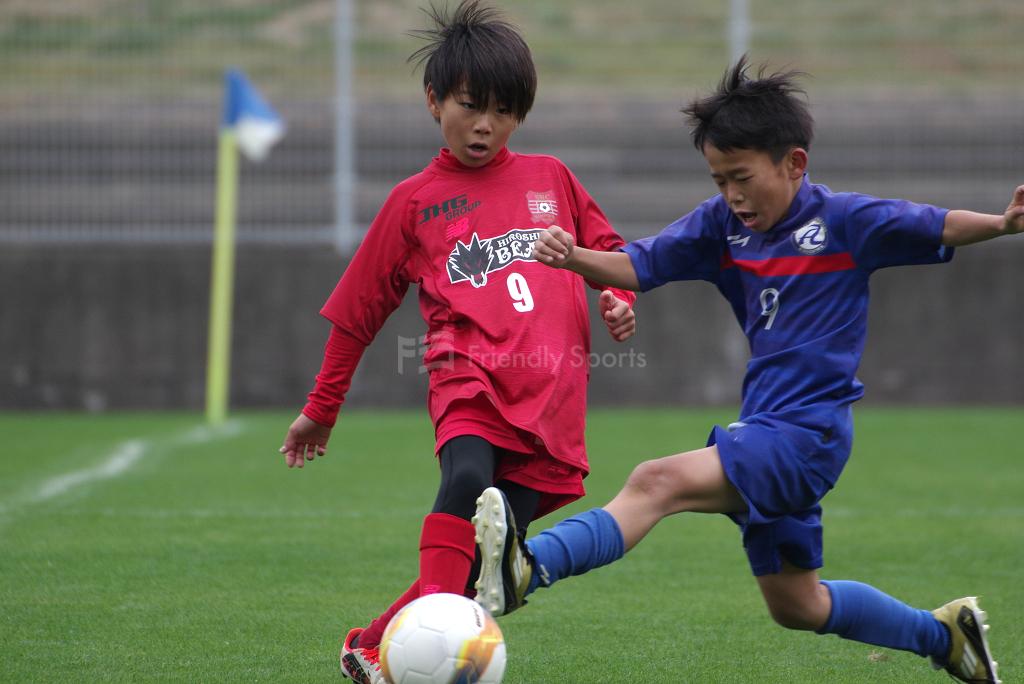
<box><xmin>427</xmin><ymin>86</ymin><xmax>519</xmax><ymax>167</ymax></box>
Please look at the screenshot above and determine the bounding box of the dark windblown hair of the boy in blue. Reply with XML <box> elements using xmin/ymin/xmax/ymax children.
<box><xmin>682</xmin><ymin>54</ymin><xmax>814</xmax><ymax>163</ymax></box>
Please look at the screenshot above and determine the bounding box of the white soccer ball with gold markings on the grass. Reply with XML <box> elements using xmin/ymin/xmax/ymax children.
<box><xmin>380</xmin><ymin>594</ymin><xmax>505</xmax><ymax>684</ymax></box>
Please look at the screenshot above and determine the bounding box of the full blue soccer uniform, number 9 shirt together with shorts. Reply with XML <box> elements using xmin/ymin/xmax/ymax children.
<box><xmin>623</xmin><ymin>178</ymin><xmax>953</xmax><ymax>575</ymax></box>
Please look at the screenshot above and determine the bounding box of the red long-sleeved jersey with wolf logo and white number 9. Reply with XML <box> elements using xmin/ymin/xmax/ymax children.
<box><xmin>305</xmin><ymin>148</ymin><xmax>635</xmax><ymax>472</ymax></box>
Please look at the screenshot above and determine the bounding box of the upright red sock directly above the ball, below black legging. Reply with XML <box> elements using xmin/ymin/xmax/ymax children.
<box><xmin>420</xmin><ymin>513</ymin><xmax>476</xmax><ymax>596</ymax></box>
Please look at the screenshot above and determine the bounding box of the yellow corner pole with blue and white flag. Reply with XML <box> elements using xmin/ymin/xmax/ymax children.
<box><xmin>206</xmin><ymin>70</ymin><xmax>285</xmax><ymax>424</ymax></box>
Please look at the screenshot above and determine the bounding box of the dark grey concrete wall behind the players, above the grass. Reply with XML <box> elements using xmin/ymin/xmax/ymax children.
<box><xmin>0</xmin><ymin>240</ymin><xmax>1024</xmax><ymax>411</ymax></box>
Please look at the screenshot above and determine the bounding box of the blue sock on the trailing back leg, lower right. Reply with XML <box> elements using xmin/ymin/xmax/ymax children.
<box><xmin>818</xmin><ymin>580</ymin><xmax>949</xmax><ymax>661</ymax></box>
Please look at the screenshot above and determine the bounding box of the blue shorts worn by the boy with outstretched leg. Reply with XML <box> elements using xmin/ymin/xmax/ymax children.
<box><xmin>708</xmin><ymin>407</ymin><xmax>853</xmax><ymax>576</ymax></box>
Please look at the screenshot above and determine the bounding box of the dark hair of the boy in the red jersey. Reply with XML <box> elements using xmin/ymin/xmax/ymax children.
<box><xmin>409</xmin><ymin>0</ymin><xmax>537</xmax><ymax>122</ymax></box>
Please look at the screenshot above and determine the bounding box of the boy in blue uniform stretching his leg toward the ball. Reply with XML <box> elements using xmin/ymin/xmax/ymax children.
<box><xmin>474</xmin><ymin>57</ymin><xmax>1024</xmax><ymax>683</ymax></box>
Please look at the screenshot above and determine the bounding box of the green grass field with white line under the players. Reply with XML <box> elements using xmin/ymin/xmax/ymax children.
<box><xmin>0</xmin><ymin>409</ymin><xmax>1024</xmax><ymax>684</ymax></box>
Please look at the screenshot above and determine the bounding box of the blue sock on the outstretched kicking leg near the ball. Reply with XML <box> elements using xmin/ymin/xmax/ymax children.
<box><xmin>526</xmin><ymin>508</ymin><xmax>626</xmax><ymax>594</ymax></box>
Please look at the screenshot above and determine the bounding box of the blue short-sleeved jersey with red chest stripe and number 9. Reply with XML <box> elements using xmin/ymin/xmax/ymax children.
<box><xmin>624</xmin><ymin>178</ymin><xmax>953</xmax><ymax>418</ymax></box>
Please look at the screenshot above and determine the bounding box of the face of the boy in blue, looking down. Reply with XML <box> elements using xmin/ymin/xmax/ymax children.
<box><xmin>703</xmin><ymin>144</ymin><xmax>807</xmax><ymax>232</ymax></box>
